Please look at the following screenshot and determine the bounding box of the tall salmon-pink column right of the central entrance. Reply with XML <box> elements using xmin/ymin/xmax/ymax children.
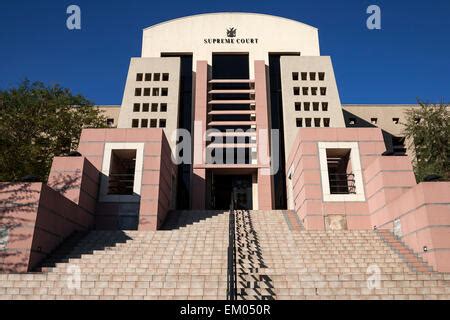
<box><xmin>255</xmin><ymin>60</ymin><xmax>273</xmax><ymax>210</ymax></box>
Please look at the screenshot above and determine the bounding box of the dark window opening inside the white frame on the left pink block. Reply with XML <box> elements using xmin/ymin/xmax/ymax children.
<box><xmin>108</xmin><ymin>149</ymin><xmax>136</xmax><ymax>195</ymax></box>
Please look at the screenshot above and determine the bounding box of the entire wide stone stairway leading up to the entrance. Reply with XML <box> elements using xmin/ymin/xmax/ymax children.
<box><xmin>0</xmin><ymin>211</ymin><xmax>450</xmax><ymax>300</ymax></box>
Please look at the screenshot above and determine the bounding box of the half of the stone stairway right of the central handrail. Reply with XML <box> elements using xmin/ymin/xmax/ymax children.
<box><xmin>236</xmin><ymin>211</ymin><xmax>450</xmax><ymax>299</ymax></box>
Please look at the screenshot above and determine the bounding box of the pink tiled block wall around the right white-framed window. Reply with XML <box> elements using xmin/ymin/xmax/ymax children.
<box><xmin>286</xmin><ymin>128</ymin><xmax>385</xmax><ymax>230</ymax></box>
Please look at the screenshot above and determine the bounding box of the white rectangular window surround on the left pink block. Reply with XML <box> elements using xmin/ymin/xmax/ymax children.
<box><xmin>99</xmin><ymin>142</ymin><xmax>144</xmax><ymax>202</ymax></box>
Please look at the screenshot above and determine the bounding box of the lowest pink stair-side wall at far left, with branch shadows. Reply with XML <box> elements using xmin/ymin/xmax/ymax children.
<box><xmin>0</xmin><ymin>183</ymin><xmax>94</xmax><ymax>272</ymax></box>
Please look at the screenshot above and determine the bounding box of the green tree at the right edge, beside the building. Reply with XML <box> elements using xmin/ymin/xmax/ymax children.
<box><xmin>404</xmin><ymin>101</ymin><xmax>450</xmax><ymax>181</ymax></box>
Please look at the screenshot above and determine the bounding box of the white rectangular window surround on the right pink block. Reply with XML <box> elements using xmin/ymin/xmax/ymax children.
<box><xmin>318</xmin><ymin>142</ymin><xmax>366</xmax><ymax>202</ymax></box>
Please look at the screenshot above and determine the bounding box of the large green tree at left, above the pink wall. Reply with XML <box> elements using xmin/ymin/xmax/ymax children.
<box><xmin>0</xmin><ymin>80</ymin><xmax>105</xmax><ymax>181</ymax></box>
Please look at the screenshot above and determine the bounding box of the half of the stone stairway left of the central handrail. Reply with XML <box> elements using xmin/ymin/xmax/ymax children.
<box><xmin>0</xmin><ymin>211</ymin><xmax>229</xmax><ymax>300</ymax></box>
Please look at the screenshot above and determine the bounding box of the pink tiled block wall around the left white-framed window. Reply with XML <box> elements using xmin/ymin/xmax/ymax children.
<box><xmin>78</xmin><ymin>128</ymin><xmax>177</xmax><ymax>230</ymax></box>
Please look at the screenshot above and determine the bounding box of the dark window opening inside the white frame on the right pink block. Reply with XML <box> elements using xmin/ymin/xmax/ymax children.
<box><xmin>326</xmin><ymin>149</ymin><xmax>356</xmax><ymax>194</ymax></box>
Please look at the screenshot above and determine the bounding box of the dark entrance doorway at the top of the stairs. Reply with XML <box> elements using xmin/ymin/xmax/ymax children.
<box><xmin>211</xmin><ymin>174</ymin><xmax>253</xmax><ymax>210</ymax></box>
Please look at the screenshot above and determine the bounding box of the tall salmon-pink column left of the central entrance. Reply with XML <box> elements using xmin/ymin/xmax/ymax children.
<box><xmin>191</xmin><ymin>61</ymin><xmax>208</xmax><ymax>210</ymax></box>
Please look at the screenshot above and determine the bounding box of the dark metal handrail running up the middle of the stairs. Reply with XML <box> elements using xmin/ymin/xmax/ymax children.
<box><xmin>227</xmin><ymin>194</ymin><xmax>237</xmax><ymax>300</ymax></box>
